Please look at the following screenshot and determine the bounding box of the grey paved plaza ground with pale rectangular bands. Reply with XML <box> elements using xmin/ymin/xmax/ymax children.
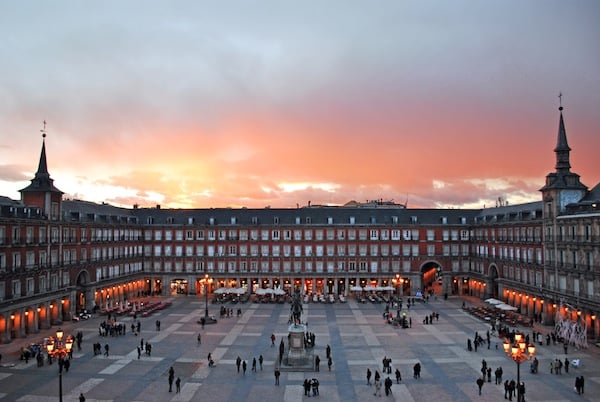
<box><xmin>0</xmin><ymin>296</ymin><xmax>600</xmax><ymax>402</ymax></box>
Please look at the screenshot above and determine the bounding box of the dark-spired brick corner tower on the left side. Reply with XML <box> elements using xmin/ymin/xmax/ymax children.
<box><xmin>19</xmin><ymin>121</ymin><xmax>64</xmax><ymax>220</ymax></box>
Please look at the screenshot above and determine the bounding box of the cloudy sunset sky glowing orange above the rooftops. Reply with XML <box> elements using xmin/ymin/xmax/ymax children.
<box><xmin>0</xmin><ymin>0</ymin><xmax>600</xmax><ymax>208</ymax></box>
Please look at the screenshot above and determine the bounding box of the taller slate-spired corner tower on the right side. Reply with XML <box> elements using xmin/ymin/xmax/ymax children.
<box><xmin>540</xmin><ymin>102</ymin><xmax>588</xmax><ymax>219</ymax></box>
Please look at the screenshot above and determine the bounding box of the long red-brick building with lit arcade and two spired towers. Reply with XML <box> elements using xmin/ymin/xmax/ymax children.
<box><xmin>0</xmin><ymin>108</ymin><xmax>600</xmax><ymax>343</ymax></box>
